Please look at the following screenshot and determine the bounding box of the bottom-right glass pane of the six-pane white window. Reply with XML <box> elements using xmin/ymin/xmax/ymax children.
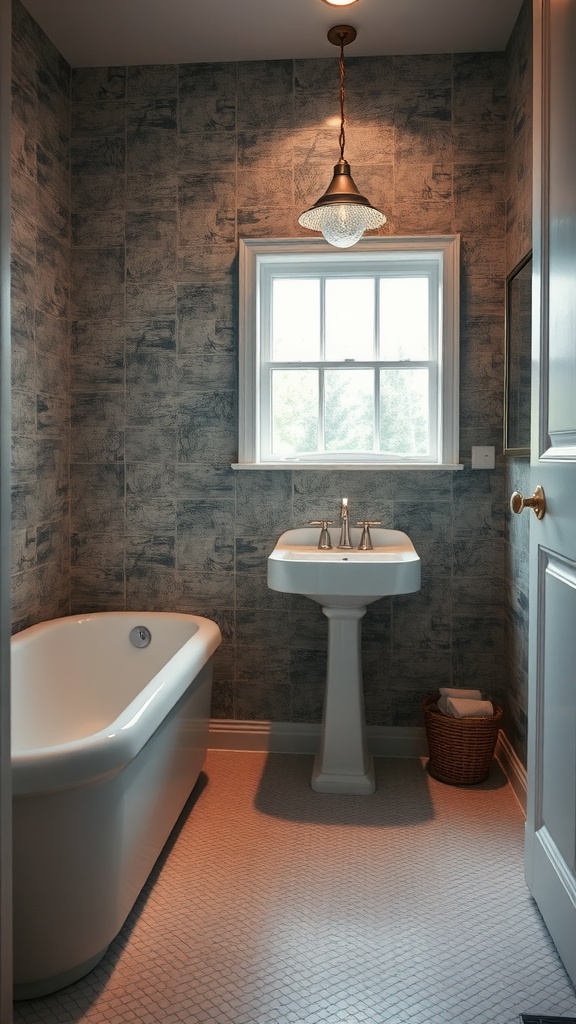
<box><xmin>380</xmin><ymin>369</ymin><xmax>429</xmax><ymax>458</ymax></box>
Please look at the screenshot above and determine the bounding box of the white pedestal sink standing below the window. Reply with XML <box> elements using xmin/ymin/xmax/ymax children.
<box><xmin>268</xmin><ymin>527</ymin><xmax>420</xmax><ymax>794</ymax></box>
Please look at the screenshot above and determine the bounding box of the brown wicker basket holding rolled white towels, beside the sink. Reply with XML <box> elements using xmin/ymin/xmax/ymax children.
<box><xmin>423</xmin><ymin>693</ymin><xmax>503</xmax><ymax>785</ymax></box>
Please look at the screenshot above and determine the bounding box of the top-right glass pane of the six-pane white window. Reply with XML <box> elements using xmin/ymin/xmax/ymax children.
<box><xmin>380</xmin><ymin>278</ymin><xmax>428</xmax><ymax>359</ymax></box>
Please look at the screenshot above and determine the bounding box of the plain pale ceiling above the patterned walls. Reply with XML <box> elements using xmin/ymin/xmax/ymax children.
<box><xmin>24</xmin><ymin>0</ymin><xmax>522</xmax><ymax>68</ymax></box>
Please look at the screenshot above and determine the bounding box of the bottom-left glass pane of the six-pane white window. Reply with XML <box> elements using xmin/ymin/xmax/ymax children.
<box><xmin>272</xmin><ymin>370</ymin><xmax>318</xmax><ymax>456</ymax></box>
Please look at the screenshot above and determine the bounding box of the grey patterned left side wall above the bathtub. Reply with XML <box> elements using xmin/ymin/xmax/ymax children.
<box><xmin>11</xmin><ymin>0</ymin><xmax>70</xmax><ymax>630</ymax></box>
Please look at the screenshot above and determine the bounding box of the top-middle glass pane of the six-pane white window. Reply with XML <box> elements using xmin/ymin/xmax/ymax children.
<box><xmin>326</xmin><ymin>278</ymin><xmax>374</xmax><ymax>360</ymax></box>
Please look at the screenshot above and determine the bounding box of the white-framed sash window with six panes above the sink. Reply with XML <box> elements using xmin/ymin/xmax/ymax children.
<box><xmin>235</xmin><ymin>237</ymin><xmax>458</xmax><ymax>466</ymax></box>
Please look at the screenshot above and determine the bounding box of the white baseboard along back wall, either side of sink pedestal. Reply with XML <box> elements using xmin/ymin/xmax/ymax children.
<box><xmin>208</xmin><ymin>719</ymin><xmax>427</xmax><ymax>758</ymax></box>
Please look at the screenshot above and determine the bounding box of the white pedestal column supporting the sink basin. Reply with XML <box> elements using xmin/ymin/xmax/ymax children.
<box><xmin>312</xmin><ymin>606</ymin><xmax>376</xmax><ymax>794</ymax></box>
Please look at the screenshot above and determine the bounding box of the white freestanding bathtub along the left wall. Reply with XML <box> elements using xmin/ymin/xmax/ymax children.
<box><xmin>12</xmin><ymin>611</ymin><xmax>221</xmax><ymax>998</ymax></box>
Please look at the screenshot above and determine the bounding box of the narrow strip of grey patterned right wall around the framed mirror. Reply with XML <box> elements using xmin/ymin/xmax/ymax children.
<box><xmin>504</xmin><ymin>0</ymin><xmax>532</xmax><ymax>763</ymax></box>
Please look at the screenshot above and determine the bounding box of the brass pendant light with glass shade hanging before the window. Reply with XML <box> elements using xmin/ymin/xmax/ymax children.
<box><xmin>298</xmin><ymin>25</ymin><xmax>386</xmax><ymax>249</ymax></box>
